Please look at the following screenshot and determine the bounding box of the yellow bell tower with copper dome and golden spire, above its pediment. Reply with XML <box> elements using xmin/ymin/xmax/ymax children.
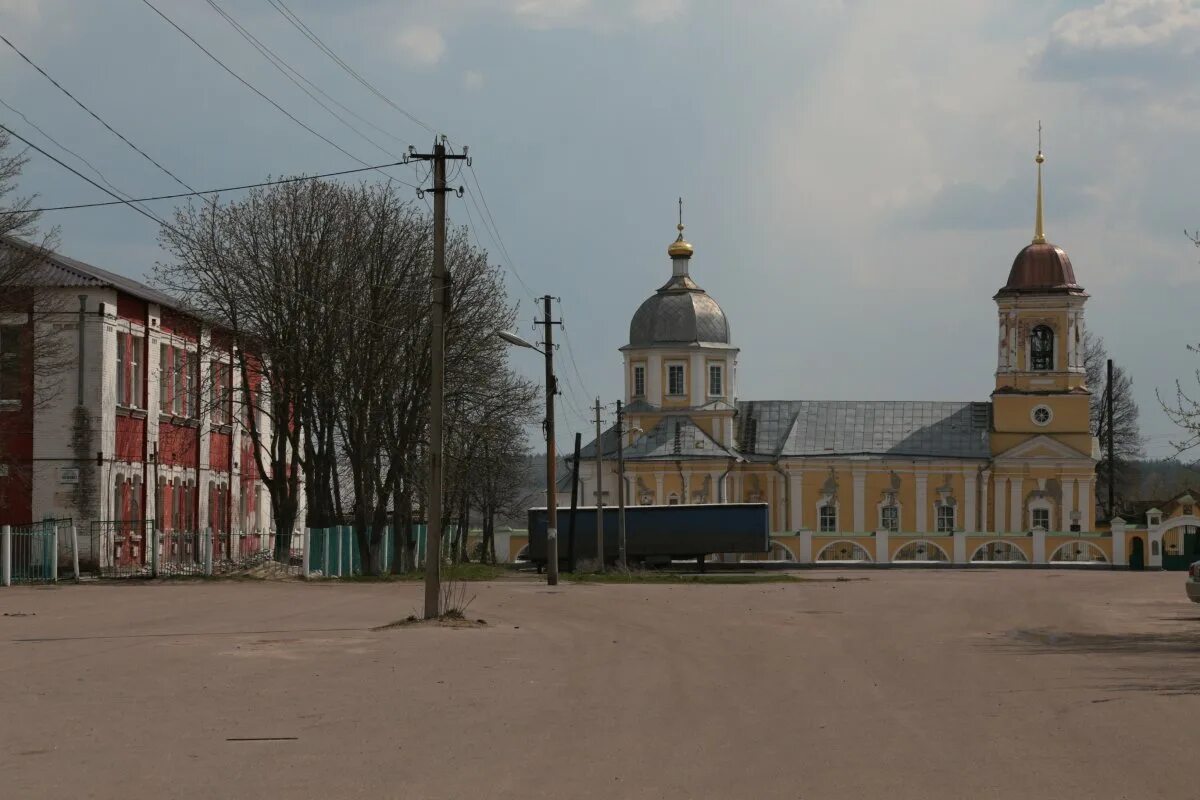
<box><xmin>992</xmin><ymin>140</ymin><xmax>1092</xmax><ymax>456</ymax></box>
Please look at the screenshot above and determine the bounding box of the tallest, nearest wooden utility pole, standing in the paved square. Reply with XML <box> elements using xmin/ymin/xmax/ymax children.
<box><xmin>404</xmin><ymin>137</ymin><xmax>470</xmax><ymax>619</ymax></box>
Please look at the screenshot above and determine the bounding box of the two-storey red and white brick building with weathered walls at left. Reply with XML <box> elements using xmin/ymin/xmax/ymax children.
<box><xmin>0</xmin><ymin>243</ymin><xmax>271</xmax><ymax>564</ymax></box>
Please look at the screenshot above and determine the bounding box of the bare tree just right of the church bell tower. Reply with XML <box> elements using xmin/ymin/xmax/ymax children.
<box><xmin>1082</xmin><ymin>331</ymin><xmax>1144</xmax><ymax>517</ymax></box>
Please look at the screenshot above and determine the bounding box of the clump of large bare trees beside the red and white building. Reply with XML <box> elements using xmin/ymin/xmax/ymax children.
<box><xmin>156</xmin><ymin>181</ymin><xmax>539</xmax><ymax>573</ymax></box>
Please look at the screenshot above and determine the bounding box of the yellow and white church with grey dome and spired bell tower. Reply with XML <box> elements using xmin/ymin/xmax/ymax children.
<box><xmin>580</xmin><ymin>150</ymin><xmax>1124</xmax><ymax>564</ymax></box>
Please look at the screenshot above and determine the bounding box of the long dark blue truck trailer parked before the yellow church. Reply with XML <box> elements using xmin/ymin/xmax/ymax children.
<box><xmin>528</xmin><ymin>503</ymin><xmax>770</xmax><ymax>566</ymax></box>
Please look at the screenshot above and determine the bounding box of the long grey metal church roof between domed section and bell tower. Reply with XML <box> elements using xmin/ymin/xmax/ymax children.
<box><xmin>738</xmin><ymin>401</ymin><xmax>991</xmax><ymax>459</ymax></box>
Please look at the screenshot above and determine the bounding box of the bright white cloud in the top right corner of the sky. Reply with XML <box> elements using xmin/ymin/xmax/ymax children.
<box><xmin>1032</xmin><ymin>0</ymin><xmax>1200</xmax><ymax>87</ymax></box>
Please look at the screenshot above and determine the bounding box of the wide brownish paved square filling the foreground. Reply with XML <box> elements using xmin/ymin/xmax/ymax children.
<box><xmin>0</xmin><ymin>570</ymin><xmax>1200</xmax><ymax>800</ymax></box>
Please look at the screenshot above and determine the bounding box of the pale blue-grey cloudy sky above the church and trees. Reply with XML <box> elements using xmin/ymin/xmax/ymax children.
<box><xmin>0</xmin><ymin>0</ymin><xmax>1200</xmax><ymax>457</ymax></box>
